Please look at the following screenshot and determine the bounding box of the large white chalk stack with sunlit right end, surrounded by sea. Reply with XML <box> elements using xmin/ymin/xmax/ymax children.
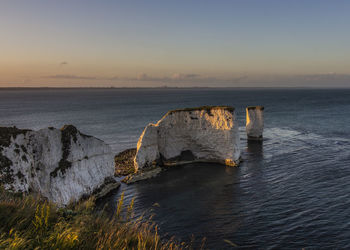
<box><xmin>134</xmin><ymin>106</ymin><xmax>240</xmax><ymax>169</ymax></box>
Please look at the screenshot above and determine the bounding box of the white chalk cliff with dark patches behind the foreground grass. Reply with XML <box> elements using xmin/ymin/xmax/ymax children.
<box><xmin>0</xmin><ymin>125</ymin><xmax>117</xmax><ymax>205</ymax></box>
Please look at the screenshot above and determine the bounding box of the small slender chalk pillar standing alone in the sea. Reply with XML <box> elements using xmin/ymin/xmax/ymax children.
<box><xmin>246</xmin><ymin>106</ymin><xmax>264</xmax><ymax>140</ymax></box>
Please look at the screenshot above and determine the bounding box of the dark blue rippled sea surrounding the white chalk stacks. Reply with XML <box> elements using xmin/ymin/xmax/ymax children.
<box><xmin>0</xmin><ymin>88</ymin><xmax>350</xmax><ymax>249</ymax></box>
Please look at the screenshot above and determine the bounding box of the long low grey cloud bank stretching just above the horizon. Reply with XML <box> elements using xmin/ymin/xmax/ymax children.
<box><xmin>37</xmin><ymin>72</ymin><xmax>350</xmax><ymax>87</ymax></box>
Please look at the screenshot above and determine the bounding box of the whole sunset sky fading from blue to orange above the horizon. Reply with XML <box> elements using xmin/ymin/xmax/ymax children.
<box><xmin>0</xmin><ymin>0</ymin><xmax>350</xmax><ymax>87</ymax></box>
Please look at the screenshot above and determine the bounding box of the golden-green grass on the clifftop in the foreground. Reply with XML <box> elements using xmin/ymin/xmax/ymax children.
<box><xmin>0</xmin><ymin>188</ymin><xmax>200</xmax><ymax>249</ymax></box>
